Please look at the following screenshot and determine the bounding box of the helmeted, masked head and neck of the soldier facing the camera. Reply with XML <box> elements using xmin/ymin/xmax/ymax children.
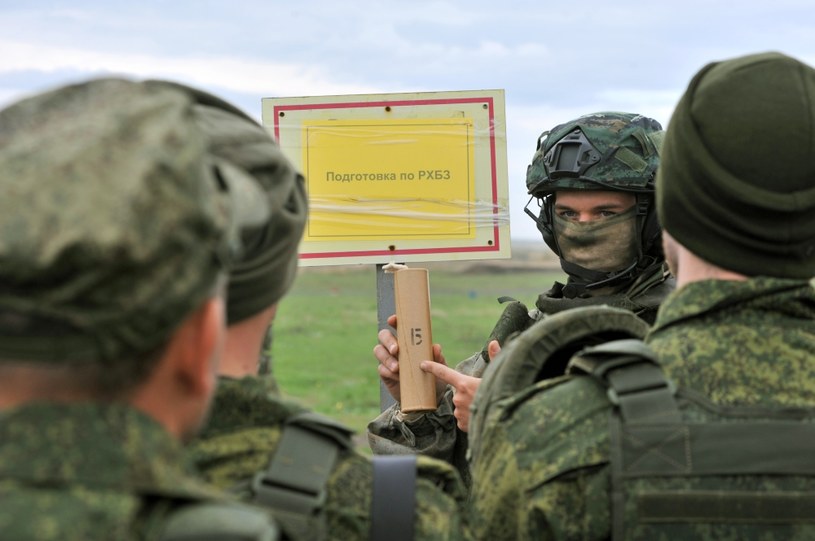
<box><xmin>524</xmin><ymin>112</ymin><xmax>673</xmax><ymax>323</ymax></box>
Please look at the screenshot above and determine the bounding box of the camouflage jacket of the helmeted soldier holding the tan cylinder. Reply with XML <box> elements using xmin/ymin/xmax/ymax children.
<box><xmin>368</xmin><ymin>265</ymin><xmax>675</xmax><ymax>487</ymax></box>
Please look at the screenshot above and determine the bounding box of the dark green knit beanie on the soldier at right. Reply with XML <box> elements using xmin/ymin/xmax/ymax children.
<box><xmin>657</xmin><ymin>53</ymin><xmax>815</xmax><ymax>279</ymax></box>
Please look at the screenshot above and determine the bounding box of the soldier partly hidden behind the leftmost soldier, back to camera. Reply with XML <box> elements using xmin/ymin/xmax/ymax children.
<box><xmin>181</xmin><ymin>99</ymin><xmax>467</xmax><ymax>541</ymax></box>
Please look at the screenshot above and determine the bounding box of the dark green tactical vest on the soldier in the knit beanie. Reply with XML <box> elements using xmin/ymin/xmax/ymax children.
<box><xmin>567</xmin><ymin>340</ymin><xmax>815</xmax><ymax>540</ymax></box>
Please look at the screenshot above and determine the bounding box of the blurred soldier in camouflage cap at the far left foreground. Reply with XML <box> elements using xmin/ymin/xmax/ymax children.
<box><xmin>0</xmin><ymin>79</ymin><xmax>284</xmax><ymax>540</ymax></box>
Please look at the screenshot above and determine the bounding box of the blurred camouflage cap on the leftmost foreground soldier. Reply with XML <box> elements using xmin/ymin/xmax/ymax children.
<box><xmin>0</xmin><ymin>79</ymin><xmax>268</xmax><ymax>363</ymax></box>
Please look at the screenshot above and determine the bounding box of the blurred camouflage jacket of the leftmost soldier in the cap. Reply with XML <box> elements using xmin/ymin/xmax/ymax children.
<box><xmin>0</xmin><ymin>403</ymin><xmax>277</xmax><ymax>541</ymax></box>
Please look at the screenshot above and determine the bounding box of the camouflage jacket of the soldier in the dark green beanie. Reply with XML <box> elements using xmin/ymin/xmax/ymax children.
<box><xmin>471</xmin><ymin>278</ymin><xmax>815</xmax><ymax>540</ymax></box>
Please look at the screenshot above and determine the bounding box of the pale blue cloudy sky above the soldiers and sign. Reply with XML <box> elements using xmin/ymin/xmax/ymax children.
<box><xmin>0</xmin><ymin>0</ymin><xmax>815</xmax><ymax>239</ymax></box>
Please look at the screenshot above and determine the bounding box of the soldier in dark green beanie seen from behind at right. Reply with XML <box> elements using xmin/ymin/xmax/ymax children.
<box><xmin>470</xmin><ymin>49</ymin><xmax>815</xmax><ymax>540</ymax></box>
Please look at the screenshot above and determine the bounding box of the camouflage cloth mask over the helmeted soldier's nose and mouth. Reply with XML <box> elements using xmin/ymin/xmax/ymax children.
<box><xmin>554</xmin><ymin>206</ymin><xmax>638</xmax><ymax>272</ymax></box>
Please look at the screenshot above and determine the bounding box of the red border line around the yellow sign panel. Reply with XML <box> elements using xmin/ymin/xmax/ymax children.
<box><xmin>272</xmin><ymin>97</ymin><xmax>501</xmax><ymax>259</ymax></box>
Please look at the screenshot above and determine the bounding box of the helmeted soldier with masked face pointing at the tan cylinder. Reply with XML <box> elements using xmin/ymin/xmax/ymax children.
<box><xmin>368</xmin><ymin>112</ymin><xmax>674</xmax><ymax>488</ymax></box>
